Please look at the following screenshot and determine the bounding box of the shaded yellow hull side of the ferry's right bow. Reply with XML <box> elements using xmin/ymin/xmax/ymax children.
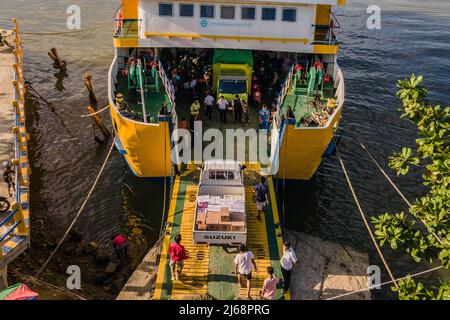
<box><xmin>278</xmin><ymin>109</ymin><xmax>342</xmax><ymax>180</ymax></box>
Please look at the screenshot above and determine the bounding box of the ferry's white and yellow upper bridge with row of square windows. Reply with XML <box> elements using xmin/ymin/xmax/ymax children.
<box><xmin>115</xmin><ymin>0</ymin><xmax>345</xmax><ymax>54</ymax></box>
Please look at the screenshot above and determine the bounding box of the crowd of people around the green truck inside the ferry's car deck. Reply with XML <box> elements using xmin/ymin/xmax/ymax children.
<box><xmin>161</xmin><ymin>49</ymin><xmax>300</xmax><ymax>129</ymax></box>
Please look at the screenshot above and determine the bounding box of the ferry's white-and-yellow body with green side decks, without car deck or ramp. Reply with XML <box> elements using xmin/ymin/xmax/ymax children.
<box><xmin>109</xmin><ymin>0</ymin><xmax>345</xmax><ymax>180</ymax></box>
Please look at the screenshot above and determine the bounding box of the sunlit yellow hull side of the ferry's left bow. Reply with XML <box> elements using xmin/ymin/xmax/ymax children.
<box><xmin>110</xmin><ymin>106</ymin><xmax>171</xmax><ymax>177</ymax></box>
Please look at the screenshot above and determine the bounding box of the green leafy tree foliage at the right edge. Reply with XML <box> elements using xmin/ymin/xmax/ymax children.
<box><xmin>372</xmin><ymin>75</ymin><xmax>450</xmax><ymax>300</ymax></box>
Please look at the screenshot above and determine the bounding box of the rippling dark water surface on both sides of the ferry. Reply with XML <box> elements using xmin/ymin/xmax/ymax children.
<box><xmin>0</xmin><ymin>0</ymin><xmax>450</xmax><ymax>298</ymax></box>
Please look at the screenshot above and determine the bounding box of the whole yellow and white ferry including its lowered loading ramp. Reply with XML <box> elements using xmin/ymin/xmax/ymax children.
<box><xmin>108</xmin><ymin>0</ymin><xmax>345</xmax><ymax>299</ymax></box>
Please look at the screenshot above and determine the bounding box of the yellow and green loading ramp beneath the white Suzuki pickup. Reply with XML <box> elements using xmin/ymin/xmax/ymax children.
<box><xmin>153</xmin><ymin>164</ymin><xmax>290</xmax><ymax>300</ymax></box>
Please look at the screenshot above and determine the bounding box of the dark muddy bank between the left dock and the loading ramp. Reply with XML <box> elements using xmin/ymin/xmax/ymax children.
<box><xmin>8</xmin><ymin>226</ymin><xmax>142</xmax><ymax>300</ymax></box>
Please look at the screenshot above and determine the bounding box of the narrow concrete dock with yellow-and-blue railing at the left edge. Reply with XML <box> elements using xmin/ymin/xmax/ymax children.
<box><xmin>0</xmin><ymin>19</ymin><xmax>30</xmax><ymax>289</ymax></box>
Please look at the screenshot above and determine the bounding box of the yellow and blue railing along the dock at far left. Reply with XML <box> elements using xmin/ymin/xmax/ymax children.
<box><xmin>0</xmin><ymin>19</ymin><xmax>29</xmax><ymax>258</ymax></box>
